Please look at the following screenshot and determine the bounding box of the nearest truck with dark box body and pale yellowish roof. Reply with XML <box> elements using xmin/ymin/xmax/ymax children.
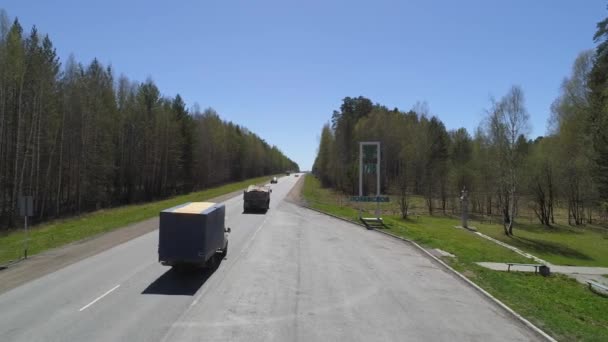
<box><xmin>158</xmin><ymin>202</ymin><xmax>230</xmax><ymax>269</ymax></box>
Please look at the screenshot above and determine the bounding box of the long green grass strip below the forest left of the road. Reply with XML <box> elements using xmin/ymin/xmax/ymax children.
<box><xmin>0</xmin><ymin>176</ymin><xmax>278</xmax><ymax>265</ymax></box>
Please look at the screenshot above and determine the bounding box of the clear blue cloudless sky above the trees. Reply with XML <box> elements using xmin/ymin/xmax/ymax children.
<box><xmin>0</xmin><ymin>0</ymin><xmax>608</xmax><ymax>169</ymax></box>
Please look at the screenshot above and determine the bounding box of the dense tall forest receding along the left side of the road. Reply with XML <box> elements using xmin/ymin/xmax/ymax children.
<box><xmin>0</xmin><ymin>11</ymin><xmax>298</xmax><ymax>229</ymax></box>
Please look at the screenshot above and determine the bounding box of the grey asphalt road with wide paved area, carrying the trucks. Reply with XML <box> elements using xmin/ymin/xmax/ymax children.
<box><xmin>0</xmin><ymin>176</ymin><xmax>536</xmax><ymax>342</ymax></box>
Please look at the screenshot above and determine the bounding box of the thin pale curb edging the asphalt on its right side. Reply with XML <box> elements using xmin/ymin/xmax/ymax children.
<box><xmin>299</xmin><ymin>204</ymin><xmax>557</xmax><ymax>342</ymax></box>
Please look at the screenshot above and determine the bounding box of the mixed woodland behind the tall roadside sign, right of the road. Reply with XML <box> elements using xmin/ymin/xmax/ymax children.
<box><xmin>313</xmin><ymin>11</ymin><xmax>608</xmax><ymax>235</ymax></box>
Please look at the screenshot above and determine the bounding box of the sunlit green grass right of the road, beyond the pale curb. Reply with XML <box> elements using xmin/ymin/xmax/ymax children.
<box><xmin>302</xmin><ymin>176</ymin><xmax>608</xmax><ymax>341</ymax></box>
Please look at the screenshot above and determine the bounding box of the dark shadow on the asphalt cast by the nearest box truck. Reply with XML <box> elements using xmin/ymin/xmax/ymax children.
<box><xmin>141</xmin><ymin>267</ymin><xmax>217</xmax><ymax>296</ymax></box>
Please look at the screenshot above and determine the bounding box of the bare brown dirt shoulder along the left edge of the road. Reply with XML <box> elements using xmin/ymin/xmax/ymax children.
<box><xmin>0</xmin><ymin>183</ymin><xmax>260</xmax><ymax>294</ymax></box>
